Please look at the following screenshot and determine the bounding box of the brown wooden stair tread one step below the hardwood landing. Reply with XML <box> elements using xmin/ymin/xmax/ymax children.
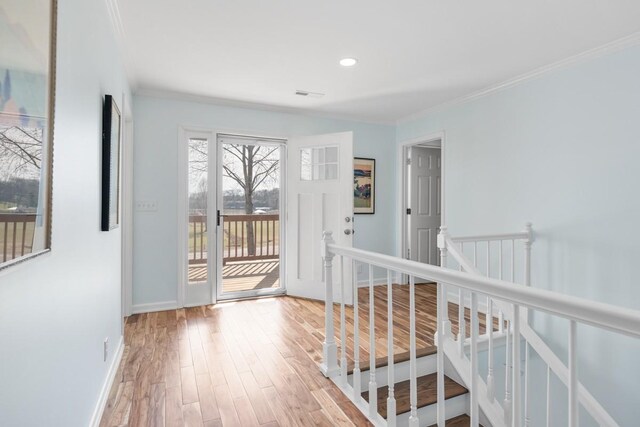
<box><xmin>362</xmin><ymin>373</ymin><xmax>468</xmax><ymax>418</ymax></box>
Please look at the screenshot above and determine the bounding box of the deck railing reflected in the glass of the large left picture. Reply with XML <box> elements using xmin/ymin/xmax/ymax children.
<box><xmin>0</xmin><ymin>213</ymin><xmax>37</xmax><ymax>262</ymax></box>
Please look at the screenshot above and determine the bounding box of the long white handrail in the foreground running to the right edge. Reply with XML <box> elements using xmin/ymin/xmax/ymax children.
<box><xmin>327</xmin><ymin>243</ymin><xmax>640</xmax><ymax>338</ymax></box>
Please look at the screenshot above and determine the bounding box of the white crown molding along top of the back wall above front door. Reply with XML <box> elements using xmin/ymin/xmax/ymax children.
<box><xmin>134</xmin><ymin>88</ymin><xmax>396</xmax><ymax>126</ymax></box>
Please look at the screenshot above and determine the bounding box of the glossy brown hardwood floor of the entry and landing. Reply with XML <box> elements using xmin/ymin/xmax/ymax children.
<box><xmin>100</xmin><ymin>285</ymin><xmax>484</xmax><ymax>427</ymax></box>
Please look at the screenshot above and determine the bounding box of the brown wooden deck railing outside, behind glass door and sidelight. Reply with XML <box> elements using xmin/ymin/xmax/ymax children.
<box><xmin>189</xmin><ymin>214</ymin><xmax>280</xmax><ymax>264</ymax></box>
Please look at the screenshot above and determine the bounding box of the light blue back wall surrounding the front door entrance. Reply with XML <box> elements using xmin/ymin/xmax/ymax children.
<box><xmin>133</xmin><ymin>96</ymin><xmax>395</xmax><ymax>308</ymax></box>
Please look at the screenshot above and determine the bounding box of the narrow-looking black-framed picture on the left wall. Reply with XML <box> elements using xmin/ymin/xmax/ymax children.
<box><xmin>101</xmin><ymin>95</ymin><xmax>120</xmax><ymax>231</ymax></box>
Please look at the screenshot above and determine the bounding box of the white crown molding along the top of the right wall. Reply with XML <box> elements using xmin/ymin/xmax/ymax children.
<box><xmin>395</xmin><ymin>32</ymin><xmax>640</xmax><ymax>125</ymax></box>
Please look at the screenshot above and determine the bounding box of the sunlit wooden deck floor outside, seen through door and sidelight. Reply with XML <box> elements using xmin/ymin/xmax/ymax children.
<box><xmin>189</xmin><ymin>260</ymin><xmax>280</xmax><ymax>293</ymax></box>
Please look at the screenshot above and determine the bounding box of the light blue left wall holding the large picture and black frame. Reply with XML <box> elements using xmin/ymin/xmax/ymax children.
<box><xmin>0</xmin><ymin>0</ymin><xmax>130</xmax><ymax>427</ymax></box>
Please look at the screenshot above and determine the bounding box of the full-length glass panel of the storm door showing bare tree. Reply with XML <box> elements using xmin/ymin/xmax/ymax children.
<box><xmin>218</xmin><ymin>136</ymin><xmax>284</xmax><ymax>299</ymax></box>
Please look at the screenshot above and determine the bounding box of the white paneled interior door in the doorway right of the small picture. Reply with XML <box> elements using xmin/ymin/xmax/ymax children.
<box><xmin>409</xmin><ymin>147</ymin><xmax>442</xmax><ymax>265</ymax></box>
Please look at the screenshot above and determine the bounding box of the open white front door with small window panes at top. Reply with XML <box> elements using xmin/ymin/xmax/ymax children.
<box><xmin>286</xmin><ymin>132</ymin><xmax>353</xmax><ymax>303</ymax></box>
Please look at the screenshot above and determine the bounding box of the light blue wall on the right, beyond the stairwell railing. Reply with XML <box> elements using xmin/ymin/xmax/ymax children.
<box><xmin>397</xmin><ymin>47</ymin><xmax>640</xmax><ymax>425</ymax></box>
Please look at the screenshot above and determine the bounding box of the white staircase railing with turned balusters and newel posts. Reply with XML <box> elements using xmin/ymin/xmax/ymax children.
<box><xmin>321</xmin><ymin>224</ymin><xmax>640</xmax><ymax>427</ymax></box>
